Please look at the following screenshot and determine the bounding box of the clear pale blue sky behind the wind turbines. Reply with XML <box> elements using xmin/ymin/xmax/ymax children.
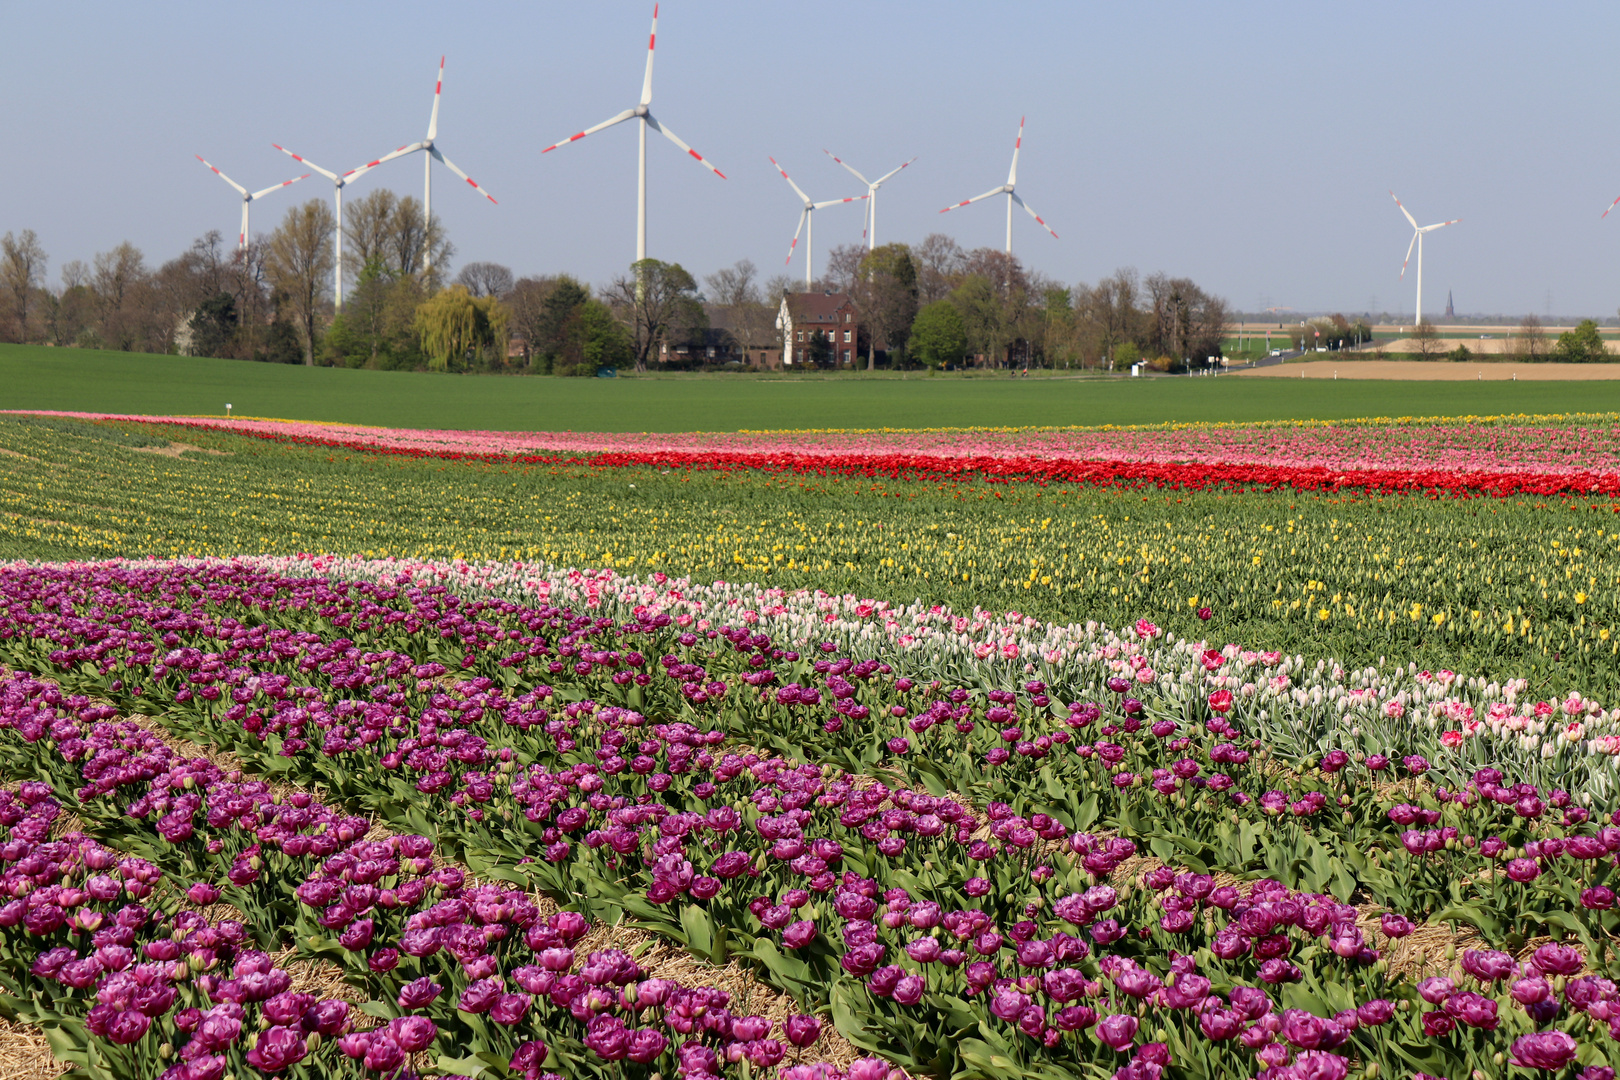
<box><xmin>9</xmin><ymin>0</ymin><xmax>1620</xmax><ymax>317</ymax></box>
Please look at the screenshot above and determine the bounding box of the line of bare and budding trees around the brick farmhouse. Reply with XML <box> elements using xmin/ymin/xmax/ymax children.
<box><xmin>0</xmin><ymin>196</ymin><xmax>1230</xmax><ymax>374</ymax></box>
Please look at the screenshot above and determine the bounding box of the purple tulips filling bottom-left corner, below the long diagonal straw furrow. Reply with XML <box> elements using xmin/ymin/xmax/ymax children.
<box><xmin>0</xmin><ymin>672</ymin><xmax>861</xmax><ymax>1080</ymax></box>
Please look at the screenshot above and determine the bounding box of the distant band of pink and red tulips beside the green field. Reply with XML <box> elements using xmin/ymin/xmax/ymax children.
<box><xmin>9</xmin><ymin>413</ymin><xmax>1620</xmax><ymax>499</ymax></box>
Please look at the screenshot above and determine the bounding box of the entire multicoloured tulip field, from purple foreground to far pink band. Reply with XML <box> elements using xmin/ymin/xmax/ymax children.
<box><xmin>0</xmin><ymin>415</ymin><xmax>1620</xmax><ymax>1080</ymax></box>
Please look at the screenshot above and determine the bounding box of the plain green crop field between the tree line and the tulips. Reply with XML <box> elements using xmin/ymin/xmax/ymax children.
<box><xmin>0</xmin><ymin>345</ymin><xmax>1620</xmax><ymax>431</ymax></box>
